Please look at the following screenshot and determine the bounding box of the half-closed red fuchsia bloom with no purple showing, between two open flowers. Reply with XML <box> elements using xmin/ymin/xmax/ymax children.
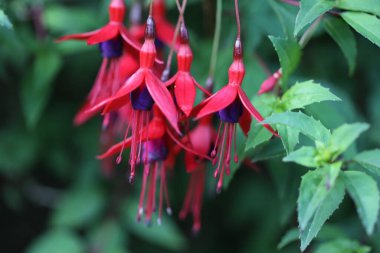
<box><xmin>165</xmin><ymin>23</ymin><xmax>210</xmax><ymax>117</ymax></box>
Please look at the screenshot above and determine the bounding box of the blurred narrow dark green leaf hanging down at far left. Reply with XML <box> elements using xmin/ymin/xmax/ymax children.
<box><xmin>21</xmin><ymin>50</ymin><xmax>62</xmax><ymax>128</ymax></box>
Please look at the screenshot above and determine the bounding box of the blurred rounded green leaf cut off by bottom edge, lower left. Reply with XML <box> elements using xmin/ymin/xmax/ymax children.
<box><xmin>26</xmin><ymin>230</ymin><xmax>86</xmax><ymax>253</ymax></box>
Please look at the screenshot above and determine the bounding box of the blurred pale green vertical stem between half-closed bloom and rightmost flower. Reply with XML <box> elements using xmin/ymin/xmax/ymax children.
<box><xmin>206</xmin><ymin>0</ymin><xmax>223</xmax><ymax>93</ymax></box>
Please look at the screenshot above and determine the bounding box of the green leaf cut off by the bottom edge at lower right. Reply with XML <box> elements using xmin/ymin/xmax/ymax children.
<box><xmin>314</xmin><ymin>238</ymin><xmax>371</xmax><ymax>253</ymax></box>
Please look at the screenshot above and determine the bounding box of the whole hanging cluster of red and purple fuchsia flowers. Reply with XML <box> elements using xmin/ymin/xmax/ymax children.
<box><xmin>59</xmin><ymin>0</ymin><xmax>277</xmax><ymax>232</ymax></box>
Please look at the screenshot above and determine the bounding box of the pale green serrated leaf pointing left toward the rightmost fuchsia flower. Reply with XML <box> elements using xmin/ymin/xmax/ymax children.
<box><xmin>262</xmin><ymin>112</ymin><xmax>331</xmax><ymax>143</ymax></box>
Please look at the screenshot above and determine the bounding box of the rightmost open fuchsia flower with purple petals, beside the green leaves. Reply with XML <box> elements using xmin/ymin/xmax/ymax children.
<box><xmin>194</xmin><ymin>37</ymin><xmax>278</xmax><ymax>191</ymax></box>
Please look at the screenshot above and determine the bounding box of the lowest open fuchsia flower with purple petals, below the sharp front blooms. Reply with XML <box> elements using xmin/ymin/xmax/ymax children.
<box><xmin>98</xmin><ymin>106</ymin><xmax>211</xmax><ymax>224</ymax></box>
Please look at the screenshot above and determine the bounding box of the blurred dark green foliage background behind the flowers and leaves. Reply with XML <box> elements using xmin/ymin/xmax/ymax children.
<box><xmin>0</xmin><ymin>0</ymin><xmax>380</xmax><ymax>253</ymax></box>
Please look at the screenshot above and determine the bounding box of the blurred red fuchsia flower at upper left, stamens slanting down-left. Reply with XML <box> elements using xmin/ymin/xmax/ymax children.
<box><xmin>58</xmin><ymin>0</ymin><xmax>145</xmax><ymax>125</ymax></box>
